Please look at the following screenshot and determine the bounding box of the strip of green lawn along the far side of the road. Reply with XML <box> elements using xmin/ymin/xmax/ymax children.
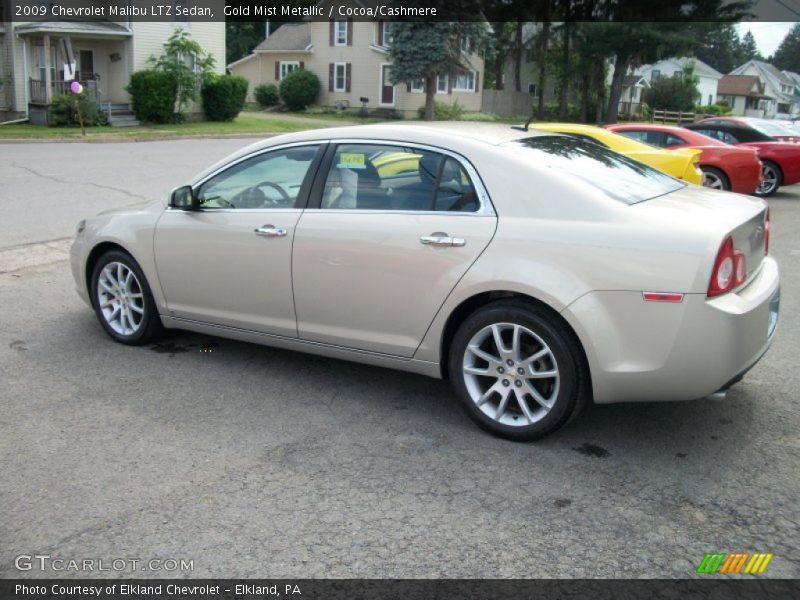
<box><xmin>0</xmin><ymin>114</ymin><xmax>325</xmax><ymax>140</ymax></box>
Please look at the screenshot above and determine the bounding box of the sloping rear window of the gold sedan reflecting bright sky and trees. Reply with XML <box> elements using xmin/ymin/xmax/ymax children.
<box><xmin>503</xmin><ymin>135</ymin><xmax>685</xmax><ymax>204</ymax></box>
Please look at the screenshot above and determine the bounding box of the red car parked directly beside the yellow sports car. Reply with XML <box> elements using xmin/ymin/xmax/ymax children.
<box><xmin>607</xmin><ymin>123</ymin><xmax>761</xmax><ymax>194</ymax></box>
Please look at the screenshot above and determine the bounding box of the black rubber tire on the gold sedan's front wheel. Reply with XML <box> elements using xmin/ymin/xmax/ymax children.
<box><xmin>89</xmin><ymin>250</ymin><xmax>163</xmax><ymax>346</ymax></box>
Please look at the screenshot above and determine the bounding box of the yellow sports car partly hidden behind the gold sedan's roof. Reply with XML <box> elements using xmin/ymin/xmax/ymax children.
<box><xmin>531</xmin><ymin>123</ymin><xmax>703</xmax><ymax>185</ymax></box>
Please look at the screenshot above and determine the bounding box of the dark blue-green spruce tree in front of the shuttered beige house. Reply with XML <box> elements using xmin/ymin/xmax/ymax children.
<box><xmin>389</xmin><ymin>21</ymin><xmax>487</xmax><ymax>121</ymax></box>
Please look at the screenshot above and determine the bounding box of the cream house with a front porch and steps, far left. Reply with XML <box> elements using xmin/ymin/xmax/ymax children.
<box><xmin>0</xmin><ymin>17</ymin><xmax>225</xmax><ymax>124</ymax></box>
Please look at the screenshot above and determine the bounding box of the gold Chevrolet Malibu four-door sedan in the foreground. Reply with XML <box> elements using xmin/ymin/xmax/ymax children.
<box><xmin>72</xmin><ymin>124</ymin><xmax>779</xmax><ymax>440</ymax></box>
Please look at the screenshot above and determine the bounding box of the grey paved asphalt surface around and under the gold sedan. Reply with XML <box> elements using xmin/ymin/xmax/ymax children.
<box><xmin>0</xmin><ymin>140</ymin><xmax>800</xmax><ymax>577</ymax></box>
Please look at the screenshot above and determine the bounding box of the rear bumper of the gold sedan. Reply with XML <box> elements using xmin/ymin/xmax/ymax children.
<box><xmin>563</xmin><ymin>257</ymin><xmax>780</xmax><ymax>404</ymax></box>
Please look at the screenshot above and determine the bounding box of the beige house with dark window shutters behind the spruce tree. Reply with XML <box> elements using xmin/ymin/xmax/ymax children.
<box><xmin>228</xmin><ymin>11</ymin><xmax>483</xmax><ymax>117</ymax></box>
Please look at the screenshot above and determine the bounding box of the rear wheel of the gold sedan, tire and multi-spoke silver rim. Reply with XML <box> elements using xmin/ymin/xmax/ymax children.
<box><xmin>448</xmin><ymin>301</ymin><xmax>583</xmax><ymax>441</ymax></box>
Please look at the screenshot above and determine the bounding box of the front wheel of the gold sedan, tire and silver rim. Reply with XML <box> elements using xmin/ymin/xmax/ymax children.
<box><xmin>91</xmin><ymin>250</ymin><xmax>162</xmax><ymax>345</ymax></box>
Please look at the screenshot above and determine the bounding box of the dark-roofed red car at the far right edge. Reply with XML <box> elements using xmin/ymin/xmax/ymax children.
<box><xmin>686</xmin><ymin>117</ymin><xmax>800</xmax><ymax>196</ymax></box>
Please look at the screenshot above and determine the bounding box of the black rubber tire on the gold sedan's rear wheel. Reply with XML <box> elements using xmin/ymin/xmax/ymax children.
<box><xmin>448</xmin><ymin>300</ymin><xmax>589</xmax><ymax>442</ymax></box>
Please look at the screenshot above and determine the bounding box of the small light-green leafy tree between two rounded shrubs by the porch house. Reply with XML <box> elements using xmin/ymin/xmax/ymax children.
<box><xmin>147</xmin><ymin>28</ymin><xmax>215</xmax><ymax>116</ymax></box>
